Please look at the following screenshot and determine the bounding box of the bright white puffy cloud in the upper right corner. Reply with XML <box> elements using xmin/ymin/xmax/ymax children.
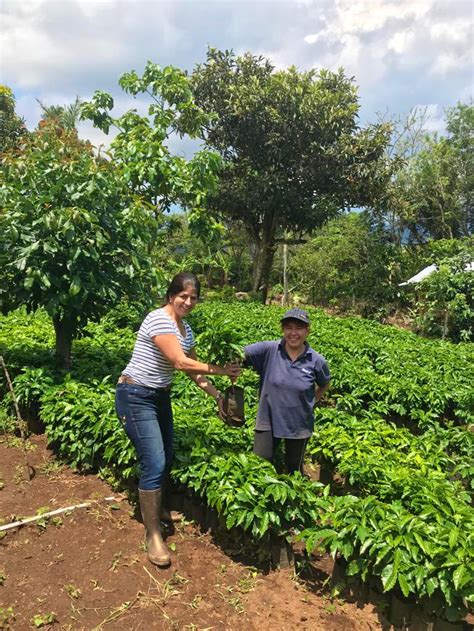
<box><xmin>302</xmin><ymin>0</ymin><xmax>474</xmax><ymax>110</ymax></box>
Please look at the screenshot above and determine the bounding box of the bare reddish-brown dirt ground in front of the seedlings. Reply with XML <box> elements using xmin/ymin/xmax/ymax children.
<box><xmin>0</xmin><ymin>436</ymin><xmax>388</xmax><ymax>631</ymax></box>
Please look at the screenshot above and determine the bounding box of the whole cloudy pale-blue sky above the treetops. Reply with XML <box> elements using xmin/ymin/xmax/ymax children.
<box><xmin>0</xmin><ymin>0</ymin><xmax>474</xmax><ymax>152</ymax></box>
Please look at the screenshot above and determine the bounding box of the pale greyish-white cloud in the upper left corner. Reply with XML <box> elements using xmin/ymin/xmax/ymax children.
<box><xmin>0</xmin><ymin>0</ymin><xmax>183</xmax><ymax>90</ymax></box>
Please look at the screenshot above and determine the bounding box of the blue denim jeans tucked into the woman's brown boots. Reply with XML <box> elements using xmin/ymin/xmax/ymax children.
<box><xmin>115</xmin><ymin>383</ymin><xmax>173</xmax><ymax>491</ymax></box>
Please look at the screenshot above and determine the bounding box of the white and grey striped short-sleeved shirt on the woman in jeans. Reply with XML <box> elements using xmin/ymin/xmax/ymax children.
<box><xmin>122</xmin><ymin>307</ymin><xmax>195</xmax><ymax>388</ymax></box>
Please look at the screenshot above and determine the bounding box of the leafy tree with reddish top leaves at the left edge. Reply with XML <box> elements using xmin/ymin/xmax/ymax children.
<box><xmin>0</xmin><ymin>119</ymin><xmax>155</xmax><ymax>369</ymax></box>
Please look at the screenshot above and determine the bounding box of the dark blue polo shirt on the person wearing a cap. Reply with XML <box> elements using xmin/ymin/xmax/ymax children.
<box><xmin>244</xmin><ymin>338</ymin><xmax>331</xmax><ymax>438</ymax></box>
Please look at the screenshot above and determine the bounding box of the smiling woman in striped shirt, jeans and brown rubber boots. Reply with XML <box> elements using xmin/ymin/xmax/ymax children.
<box><xmin>115</xmin><ymin>272</ymin><xmax>240</xmax><ymax>567</ymax></box>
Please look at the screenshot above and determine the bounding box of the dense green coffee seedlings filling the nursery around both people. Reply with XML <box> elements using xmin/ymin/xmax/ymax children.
<box><xmin>0</xmin><ymin>302</ymin><xmax>474</xmax><ymax>629</ymax></box>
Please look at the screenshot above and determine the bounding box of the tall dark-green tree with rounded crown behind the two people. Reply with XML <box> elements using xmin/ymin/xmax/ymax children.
<box><xmin>192</xmin><ymin>49</ymin><xmax>390</xmax><ymax>300</ymax></box>
